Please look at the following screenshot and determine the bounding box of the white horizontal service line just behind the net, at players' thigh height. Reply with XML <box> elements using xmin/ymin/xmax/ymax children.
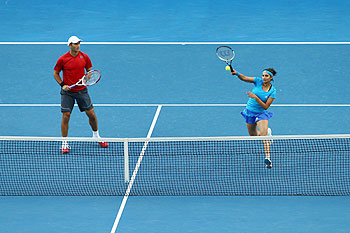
<box><xmin>0</xmin><ymin>104</ymin><xmax>350</xmax><ymax>107</ymax></box>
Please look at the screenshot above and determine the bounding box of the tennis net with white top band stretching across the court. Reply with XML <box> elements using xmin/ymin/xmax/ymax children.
<box><xmin>0</xmin><ymin>135</ymin><xmax>350</xmax><ymax>196</ymax></box>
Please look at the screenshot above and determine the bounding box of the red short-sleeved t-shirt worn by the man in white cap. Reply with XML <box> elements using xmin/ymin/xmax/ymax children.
<box><xmin>54</xmin><ymin>51</ymin><xmax>92</xmax><ymax>92</ymax></box>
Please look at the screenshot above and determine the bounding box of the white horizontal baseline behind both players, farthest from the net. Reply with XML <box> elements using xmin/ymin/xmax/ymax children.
<box><xmin>0</xmin><ymin>41</ymin><xmax>350</xmax><ymax>45</ymax></box>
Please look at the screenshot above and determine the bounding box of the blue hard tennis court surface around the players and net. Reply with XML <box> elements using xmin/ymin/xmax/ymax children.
<box><xmin>0</xmin><ymin>0</ymin><xmax>350</xmax><ymax>233</ymax></box>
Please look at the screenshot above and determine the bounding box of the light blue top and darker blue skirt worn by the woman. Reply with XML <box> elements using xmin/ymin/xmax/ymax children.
<box><xmin>241</xmin><ymin>77</ymin><xmax>276</xmax><ymax>124</ymax></box>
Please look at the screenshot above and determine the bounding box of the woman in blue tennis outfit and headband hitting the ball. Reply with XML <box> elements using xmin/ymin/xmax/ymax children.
<box><xmin>231</xmin><ymin>68</ymin><xmax>277</xmax><ymax>168</ymax></box>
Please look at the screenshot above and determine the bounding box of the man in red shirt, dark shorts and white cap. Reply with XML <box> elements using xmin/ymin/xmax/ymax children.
<box><xmin>53</xmin><ymin>36</ymin><xmax>108</xmax><ymax>153</ymax></box>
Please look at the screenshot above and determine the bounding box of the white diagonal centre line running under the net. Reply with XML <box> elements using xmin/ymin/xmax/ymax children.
<box><xmin>111</xmin><ymin>105</ymin><xmax>162</xmax><ymax>233</ymax></box>
